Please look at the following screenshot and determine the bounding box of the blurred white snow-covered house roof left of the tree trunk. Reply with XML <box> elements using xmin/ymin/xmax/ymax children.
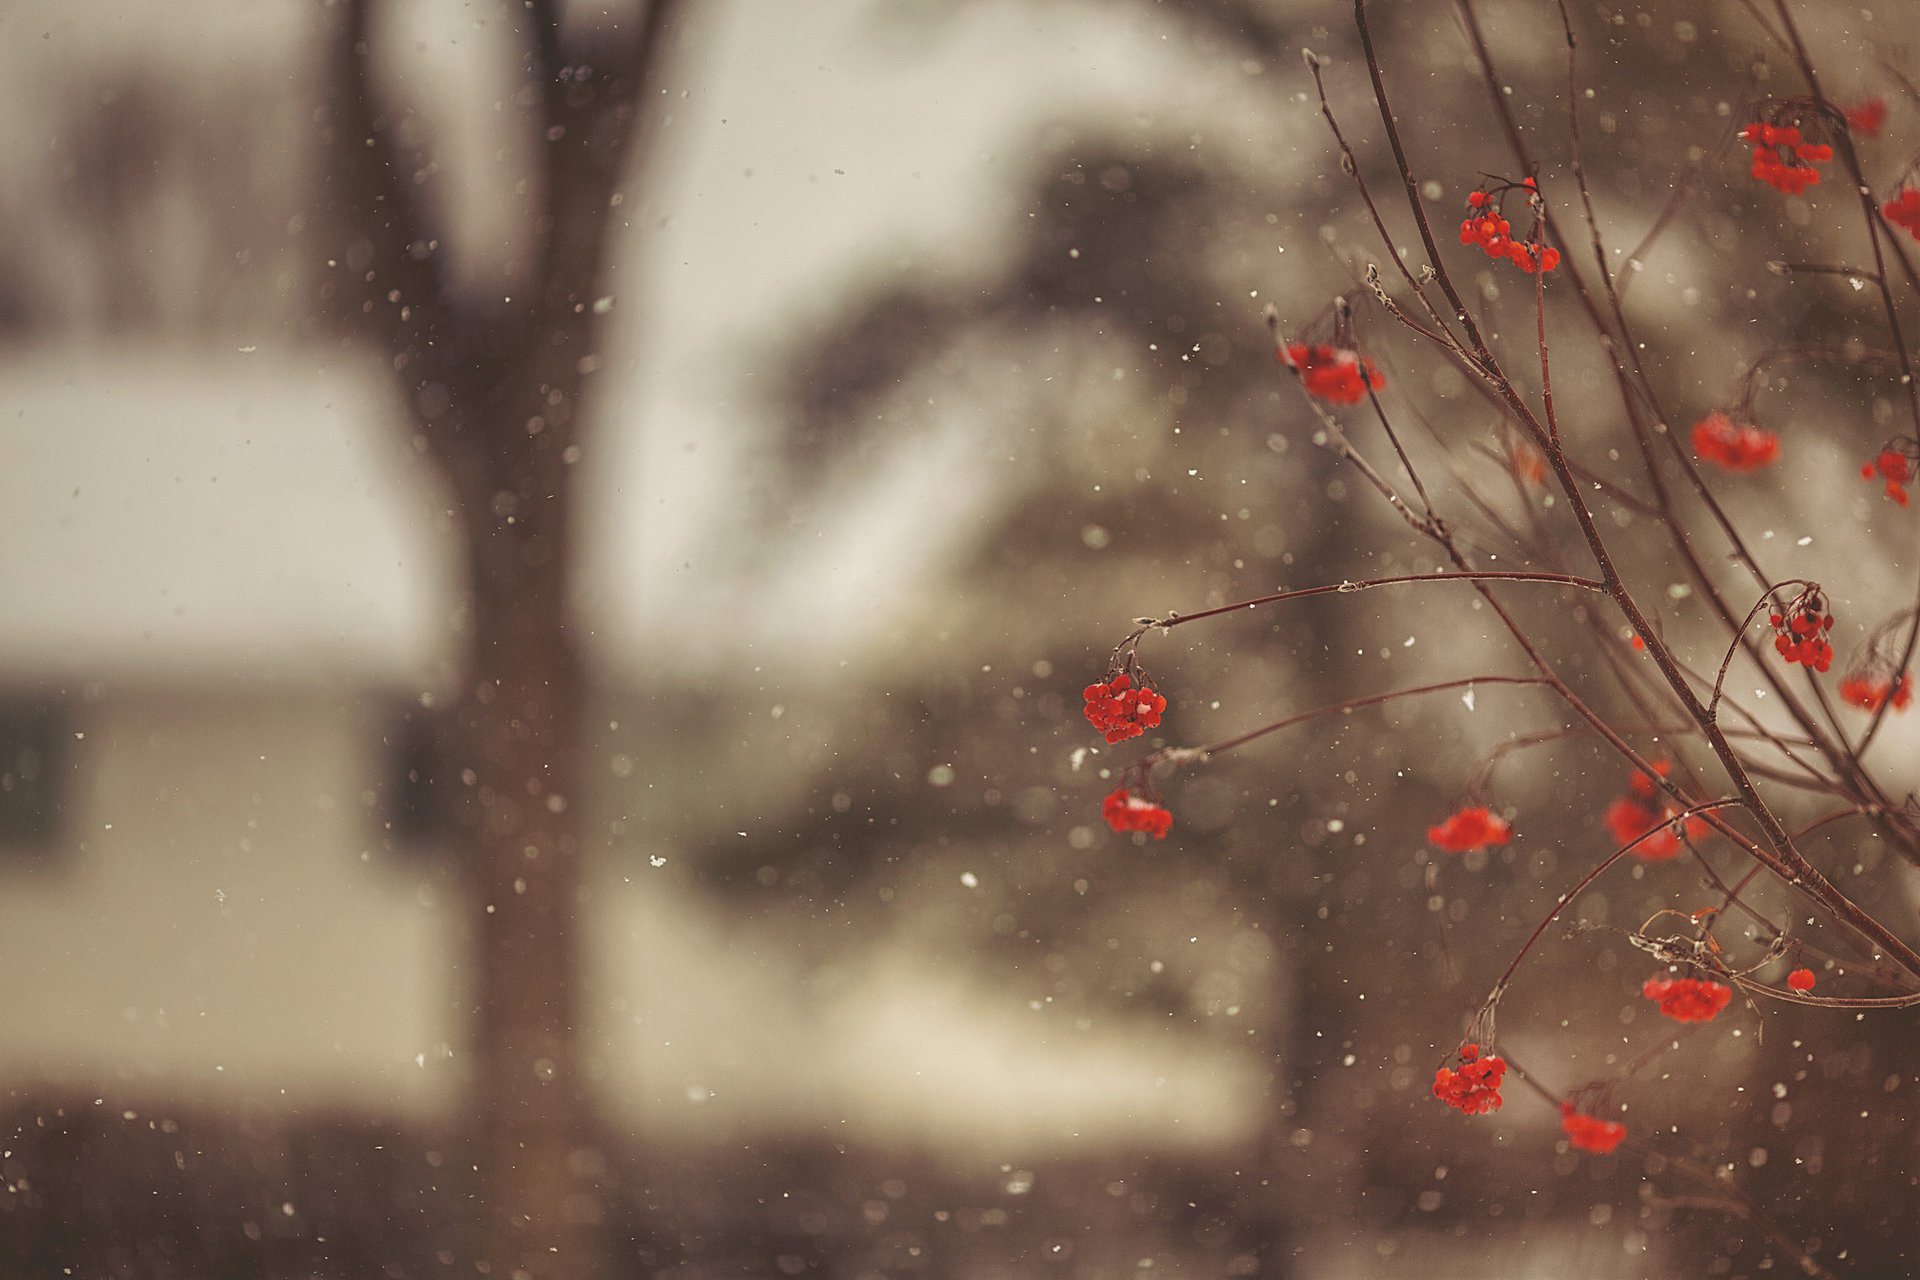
<box><xmin>0</xmin><ymin>345</ymin><xmax>457</xmax><ymax>687</ymax></box>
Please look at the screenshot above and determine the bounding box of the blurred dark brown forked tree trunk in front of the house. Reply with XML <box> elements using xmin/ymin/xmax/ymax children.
<box><xmin>323</xmin><ymin>0</ymin><xmax>678</xmax><ymax>1278</ymax></box>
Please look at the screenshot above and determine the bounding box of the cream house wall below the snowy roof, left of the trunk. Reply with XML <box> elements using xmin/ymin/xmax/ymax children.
<box><xmin>0</xmin><ymin>691</ymin><xmax>463</xmax><ymax>1113</ymax></box>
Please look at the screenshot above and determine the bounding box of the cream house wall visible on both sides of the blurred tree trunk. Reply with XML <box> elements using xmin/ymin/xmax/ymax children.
<box><xmin>0</xmin><ymin>689</ymin><xmax>1260</xmax><ymax>1157</ymax></box>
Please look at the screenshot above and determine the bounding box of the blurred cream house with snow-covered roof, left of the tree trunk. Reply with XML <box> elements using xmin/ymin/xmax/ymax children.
<box><xmin>0</xmin><ymin>349</ymin><xmax>461</xmax><ymax>1107</ymax></box>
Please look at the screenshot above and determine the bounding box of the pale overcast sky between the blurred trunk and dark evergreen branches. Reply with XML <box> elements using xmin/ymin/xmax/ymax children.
<box><xmin>589</xmin><ymin>0</ymin><xmax>1274</xmax><ymax>670</ymax></box>
